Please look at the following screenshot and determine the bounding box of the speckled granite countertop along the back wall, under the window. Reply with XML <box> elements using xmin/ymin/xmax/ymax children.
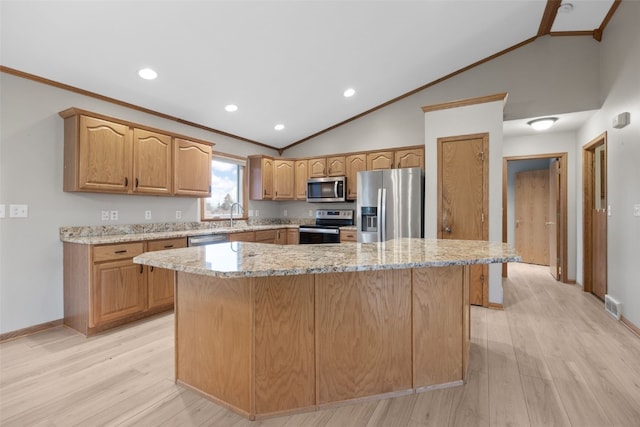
<box><xmin>60</xmin><ymin>220</ymin><xmax>304</xmax><ymax>245</ymax></box>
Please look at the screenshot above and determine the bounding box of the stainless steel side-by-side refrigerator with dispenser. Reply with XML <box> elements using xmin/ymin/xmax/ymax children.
<box><xmin>356</xmin><ymin>168</ymin><xmax>424</xmax><ymax>243</ymax></box>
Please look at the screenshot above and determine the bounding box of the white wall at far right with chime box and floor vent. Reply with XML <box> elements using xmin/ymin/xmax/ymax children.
<box><xmin>577</xmin><ymin>1</ymin><xmax>640</xmax><ymax>327</ymax></box>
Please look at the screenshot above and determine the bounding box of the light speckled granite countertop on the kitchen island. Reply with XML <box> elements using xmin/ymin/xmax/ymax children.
<box><xmin>133</xmin><ymin>238</ymin><xmax>522</xmax><ymax>278</ymax></box>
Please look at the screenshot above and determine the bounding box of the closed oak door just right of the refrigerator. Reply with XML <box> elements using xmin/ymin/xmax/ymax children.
<box><xmin>438</xmin><ymin>134</ymin><xmax>489</xmax><ymax>306</ymax></box>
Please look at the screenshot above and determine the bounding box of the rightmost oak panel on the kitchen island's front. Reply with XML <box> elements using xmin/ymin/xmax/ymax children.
<box><xmin>413</xmin><ymin>266</ymin><xmax>468</xmax><ymax>389</ymax></box>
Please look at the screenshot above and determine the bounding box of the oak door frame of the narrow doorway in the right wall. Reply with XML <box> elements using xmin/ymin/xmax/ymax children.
<box><xmin>582</xmin><ymin>132</ymin><xmax>608</xmax><ymax>293</ymax></box>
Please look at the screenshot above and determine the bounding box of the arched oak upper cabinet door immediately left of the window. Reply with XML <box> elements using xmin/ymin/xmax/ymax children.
<box><xmin>173</xmin><ymin>138</ymin><xmax>211</xmax><ymax>197</ymax></box>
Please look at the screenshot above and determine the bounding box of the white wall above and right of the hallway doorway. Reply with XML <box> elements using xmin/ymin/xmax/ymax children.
<box><xmin>502</xmin><ymin>132</ymin><xmax>582</xmax><ymax>280</ymax></box>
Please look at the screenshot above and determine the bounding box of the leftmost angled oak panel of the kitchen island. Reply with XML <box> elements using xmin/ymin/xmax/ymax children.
<box><xmin>175</xmin><ymin>271</ymin><xmax>254</xmax><ymax>417</ymax></box>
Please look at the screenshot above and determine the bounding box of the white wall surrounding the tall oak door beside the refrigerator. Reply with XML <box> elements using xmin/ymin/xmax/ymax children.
<box><xmin>424</xmin><ymin>100</ymin><xmax>504</xmax><ymax>304</ymax></box>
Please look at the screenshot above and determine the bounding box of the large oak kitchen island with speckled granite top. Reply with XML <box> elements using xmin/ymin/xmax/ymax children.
<box><xmin>133</xmin><ymin>239</ymin><xmax>520</xmax><ymax>419</ymax></box>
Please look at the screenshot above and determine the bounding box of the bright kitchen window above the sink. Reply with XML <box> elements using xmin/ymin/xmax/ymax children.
<box><xmin>200</xmin><ymin>153</ymin><xmax>246</xmax><ymax>220</ymax></box>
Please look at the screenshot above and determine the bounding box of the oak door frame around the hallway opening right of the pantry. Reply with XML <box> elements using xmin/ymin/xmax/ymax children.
<box><xmin>502</xmin><ymin>152</ymin><xmax>575</xmax><ymax>283</ymax></box>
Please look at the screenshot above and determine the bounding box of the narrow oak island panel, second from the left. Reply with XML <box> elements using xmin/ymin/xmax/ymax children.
<box><xmin>253</xmin><ymin>275</ymin><xmax>316</xmax><ymax>414</ymax></box>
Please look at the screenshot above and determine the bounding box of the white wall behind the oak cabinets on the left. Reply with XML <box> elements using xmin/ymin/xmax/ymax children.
<box><xmin>0</xmin><ymin>73</ymin><xmax>277</xmax><ymax>333</ymax></box>
